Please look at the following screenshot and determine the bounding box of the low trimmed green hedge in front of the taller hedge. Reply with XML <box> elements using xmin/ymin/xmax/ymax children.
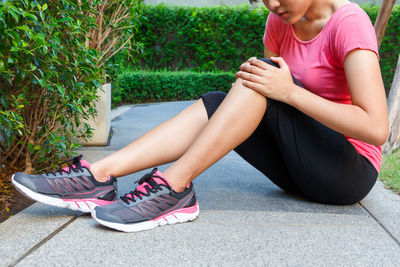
<box><xmin>112</xmin><ymin>71</ymin><xmax>235</xmax><ymax>105</ymax></box>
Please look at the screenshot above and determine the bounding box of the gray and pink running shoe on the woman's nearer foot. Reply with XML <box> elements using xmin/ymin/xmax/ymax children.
<box><xmin>92</xmin><ymin>168</ymin><xmax>199</xmax><ymax>232</ymax></box>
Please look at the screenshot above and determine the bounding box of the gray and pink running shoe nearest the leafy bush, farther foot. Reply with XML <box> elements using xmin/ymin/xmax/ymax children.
<box><xmin>11</xmin><ymin>155</ymin><xmax>117</xmax><ymax>212</ymax></box>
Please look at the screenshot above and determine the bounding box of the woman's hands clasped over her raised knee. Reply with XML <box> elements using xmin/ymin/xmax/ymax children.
<box><xmin>235</xmin><ymin>57</ymin><xmax>295</xmax><ymax>103</ymax></box>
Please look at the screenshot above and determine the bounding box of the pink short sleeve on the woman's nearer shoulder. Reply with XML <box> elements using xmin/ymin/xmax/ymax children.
<box><xmin>335</xmin><ymin>7</ymin><xmax>379</xmax><ymax>64</ymax></box>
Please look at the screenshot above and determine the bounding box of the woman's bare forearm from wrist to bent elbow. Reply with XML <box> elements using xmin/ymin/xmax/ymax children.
<box><xmin>285</xmin><ymin>84</ymin><xmax>388</xmax><ymax>146</ymax></box>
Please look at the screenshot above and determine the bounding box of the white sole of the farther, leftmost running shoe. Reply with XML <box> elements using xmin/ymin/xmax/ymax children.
<box><xmin>11</xmin><ymin>175</ymin><xmax>107</xmax><ymax>213</ymax></box>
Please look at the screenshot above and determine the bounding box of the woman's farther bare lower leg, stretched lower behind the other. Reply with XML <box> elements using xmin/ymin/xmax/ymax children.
<box><xmin>90</xmin><ymin>99</ymin><xmax>208</xmax><ymax>181</ymax></box>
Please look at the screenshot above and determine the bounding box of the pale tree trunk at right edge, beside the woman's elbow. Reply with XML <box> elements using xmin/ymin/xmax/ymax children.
<box><xmin>382</xmin><ymin>56</ymin><xmax>400</xmax><ymax>153</ymax></box>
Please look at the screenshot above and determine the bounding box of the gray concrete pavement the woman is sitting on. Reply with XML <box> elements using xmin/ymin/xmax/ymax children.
<box><xmin>0</xmin><ymin>101</ymin><xmax>400</xmax><ymax>266</ymax></box>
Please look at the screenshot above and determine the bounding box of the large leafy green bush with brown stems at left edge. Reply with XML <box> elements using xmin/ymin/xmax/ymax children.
<box><xmin>0</xmin><ymin>0</ymin><xmax>101</xmax><ymax>176</ymax></box>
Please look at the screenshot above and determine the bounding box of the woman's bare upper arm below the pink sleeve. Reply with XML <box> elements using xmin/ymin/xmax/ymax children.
<box><xmin>343</xmin><ymin>49</ymin><xmax>388</xmax><ymax>142</ymax></box>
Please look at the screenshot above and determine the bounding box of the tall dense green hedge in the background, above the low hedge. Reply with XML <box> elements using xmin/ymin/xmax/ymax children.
<box><xmin>116</xmin><ymin>5</ymin><xmax>400</xmax><ymax>91</ymax></box>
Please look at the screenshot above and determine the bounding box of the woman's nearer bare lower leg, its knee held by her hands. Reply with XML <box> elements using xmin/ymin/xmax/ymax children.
<box><xmin>164</xmin><ymin>79</ymin><xmax>267</xmax><ymax>192</ymax></box>
